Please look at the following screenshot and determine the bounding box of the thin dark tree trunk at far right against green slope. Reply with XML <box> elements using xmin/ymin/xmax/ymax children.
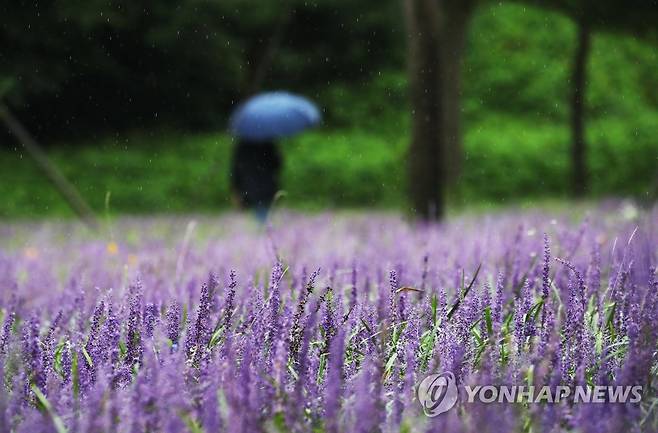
<box><xmin>571</xmin><ymin>19</ymin><xmax>590</xmax><ymax>197</ymax></box>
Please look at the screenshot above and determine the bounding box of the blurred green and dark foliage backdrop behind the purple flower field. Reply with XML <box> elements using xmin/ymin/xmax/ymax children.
<box><xmin>0</xmin><ymin>0</ymin><xmax>658</xmax><ymax>216</ymax></box>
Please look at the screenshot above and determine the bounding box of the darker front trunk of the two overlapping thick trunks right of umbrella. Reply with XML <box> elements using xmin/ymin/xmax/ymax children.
<box><xmin>404</xmin><ymin>0</ymin><xmax>444</xmax><ymax>219</ymax></box>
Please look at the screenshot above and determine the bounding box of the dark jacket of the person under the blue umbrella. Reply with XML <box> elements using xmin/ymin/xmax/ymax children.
<box><xmin>231</xmin><ymin>141</ymin><xmax>281</xmax><ymax>208</ymax></box>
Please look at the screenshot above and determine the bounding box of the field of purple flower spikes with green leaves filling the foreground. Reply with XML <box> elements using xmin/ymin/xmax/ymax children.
<box><xmin>0</xmin><ymin>205</ymin><xmax>658</xmax><ymax>433</ymax></box>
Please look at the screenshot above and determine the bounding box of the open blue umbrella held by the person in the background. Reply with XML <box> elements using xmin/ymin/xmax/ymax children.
<box><xmin>229</xmin><ymin>92</ymin><xmax>321</xmax><ymax>142</ymax></box>
